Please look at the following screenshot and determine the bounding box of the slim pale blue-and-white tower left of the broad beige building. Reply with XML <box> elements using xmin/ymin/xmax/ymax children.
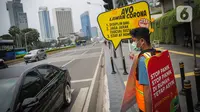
<box><xmin>38</xmin><ymin>7</ymin><xmax>52</xmax><ymax>41</ymax></box>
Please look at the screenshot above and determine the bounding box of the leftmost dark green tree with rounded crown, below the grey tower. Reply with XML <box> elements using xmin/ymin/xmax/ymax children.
<box><xmin>8</xmin><ymin>26</ymin><xmax>20</xmax><ymax>46</ymax></box>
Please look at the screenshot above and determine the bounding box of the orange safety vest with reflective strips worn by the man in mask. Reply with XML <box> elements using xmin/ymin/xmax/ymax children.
<box><xmin>134</xmin><ymin>49</ymin><xmax>160</xmax><ymax>112</ymax></box>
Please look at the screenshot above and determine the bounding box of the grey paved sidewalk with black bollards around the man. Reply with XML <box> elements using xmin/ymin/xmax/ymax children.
<box><xmin>105</xmin><ymin>44</ymin><xmax>200</xmax><ymax>112</ymax></box>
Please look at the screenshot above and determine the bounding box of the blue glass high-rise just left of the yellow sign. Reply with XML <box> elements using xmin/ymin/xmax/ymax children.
<box><xmin>81</xmin><ymin>11</ymin><xmax>92</xmax><ymax>39</ymax></box>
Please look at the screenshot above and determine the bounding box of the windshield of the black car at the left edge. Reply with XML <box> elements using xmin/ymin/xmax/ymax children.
<box><xmin>0</xmin><ymin>78</ymin><xmax>18</xmax><ymax>112</ymax></box>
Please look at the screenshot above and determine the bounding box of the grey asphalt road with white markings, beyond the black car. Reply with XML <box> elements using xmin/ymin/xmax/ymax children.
<box><xmin>10</xmin><ymin>44</ymin><xmax>102</xmax><ymax>112</ymax></box>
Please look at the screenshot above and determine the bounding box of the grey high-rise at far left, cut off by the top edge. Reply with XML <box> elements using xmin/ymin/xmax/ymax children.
<box><xmin>6</xmin><ymin>0</ymin><xmax>28</xmax><ymax>29</ymax></box>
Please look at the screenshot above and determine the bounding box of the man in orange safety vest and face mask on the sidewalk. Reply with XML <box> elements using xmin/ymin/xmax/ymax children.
<box><xmin>130</xmin><ymin>27</ymin><xmax>161</xmax><ymax>112</ymax></box>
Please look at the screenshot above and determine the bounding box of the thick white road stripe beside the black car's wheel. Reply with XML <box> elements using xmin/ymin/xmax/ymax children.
<box><xmin>70</xmin><ymin>87</ymin><xmax>88</xmax><ymax>112</ymax></box>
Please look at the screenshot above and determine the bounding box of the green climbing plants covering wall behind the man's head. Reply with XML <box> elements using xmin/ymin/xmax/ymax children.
<box><xmin>151</xmin><ymin>0</ymin><xmax>200</xmax><ymax>44</ymax></box>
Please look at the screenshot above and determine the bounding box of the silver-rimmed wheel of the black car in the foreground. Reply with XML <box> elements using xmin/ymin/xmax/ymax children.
<box><xmin>63</xmin><ymin>84</ymin><xmax>72</xmax><ymax>106</ymax></box>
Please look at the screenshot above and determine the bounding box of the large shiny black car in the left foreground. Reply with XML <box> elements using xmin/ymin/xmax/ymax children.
<box><xmin>0</xmin><ymin>64</ymin><xmax>71</xmax><ymax>112</ymax></box>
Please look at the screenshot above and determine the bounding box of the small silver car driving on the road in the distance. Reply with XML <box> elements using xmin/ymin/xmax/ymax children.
<box><xmin>24</xmin><ymin>49</ymin><xmax>47</xmax><ymax>63</ymax></box>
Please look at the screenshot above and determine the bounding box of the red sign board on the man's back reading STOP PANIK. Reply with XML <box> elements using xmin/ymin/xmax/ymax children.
<box><xmin>145</xmin><ymin>51</ymin><xmax>180</xmax><ymax>112</ymax></box>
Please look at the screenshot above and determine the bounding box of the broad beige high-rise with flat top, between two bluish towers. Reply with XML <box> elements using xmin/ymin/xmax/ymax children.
<box><xmin>53</xmin><ymin>8</ymin><xmax>74</xmax><ymax>37</ymax></box>
